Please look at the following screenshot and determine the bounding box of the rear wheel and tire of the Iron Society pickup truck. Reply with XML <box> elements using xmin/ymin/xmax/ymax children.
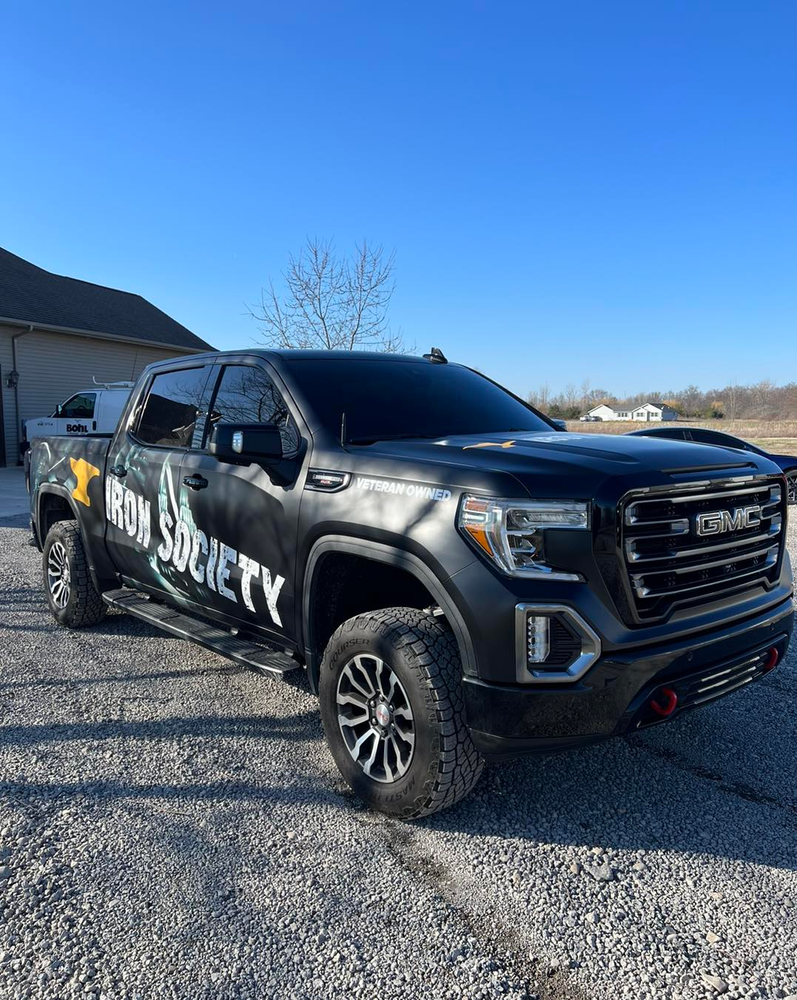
<box><xmin>42</xmin><ymin>521</ymin><xmax>108</xmax><ymax>628</ymax></box>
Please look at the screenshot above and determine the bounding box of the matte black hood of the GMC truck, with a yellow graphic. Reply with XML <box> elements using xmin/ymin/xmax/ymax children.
<box><xmin>360</xmin><ymin>431</ymin><xmax>778</xmax><ymax>498</ymax></box>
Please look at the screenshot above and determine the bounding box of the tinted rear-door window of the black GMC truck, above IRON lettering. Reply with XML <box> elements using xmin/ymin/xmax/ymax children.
<box><xmin>136</xmin><ymin>368</ymin><xmax>208</xmax><ymax>448</ymax></box>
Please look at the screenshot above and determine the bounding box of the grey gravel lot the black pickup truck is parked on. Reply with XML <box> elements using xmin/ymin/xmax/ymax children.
<box><xmin>0</xmin><ymin>519</ymin><xmax>797</xmax><ymax>1000</ymax></box>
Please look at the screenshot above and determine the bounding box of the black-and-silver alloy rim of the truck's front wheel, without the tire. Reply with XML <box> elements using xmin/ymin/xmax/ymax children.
<box><xmin>335</xmin><ymin>653</ymin><xmax>415</xmax><ymax>784</ymax></box>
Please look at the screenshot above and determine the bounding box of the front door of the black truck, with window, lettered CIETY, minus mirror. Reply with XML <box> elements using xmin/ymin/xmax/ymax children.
<box><xmin>175</xmin><ymin>360</ymin><xmax>304</xmax><ymax>643</ymax></box>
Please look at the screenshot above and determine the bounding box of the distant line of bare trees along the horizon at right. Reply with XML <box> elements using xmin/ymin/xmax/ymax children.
<box><xmin>528</xmin><ymin>379</ymin><xmax>797</xmax><ymax>420</ymax></box>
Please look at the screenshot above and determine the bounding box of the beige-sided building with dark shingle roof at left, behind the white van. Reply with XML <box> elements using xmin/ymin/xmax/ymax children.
<box><xmin>0</xmin><ymin>248</ymin><xmax>213</xmax><ymax>466</ymax></box>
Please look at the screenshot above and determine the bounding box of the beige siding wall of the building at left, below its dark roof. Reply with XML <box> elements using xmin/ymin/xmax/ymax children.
<box><xmin>0</xmin><ymin>327</ymin><xmax>188</xmax><ymax>465</ymax></box>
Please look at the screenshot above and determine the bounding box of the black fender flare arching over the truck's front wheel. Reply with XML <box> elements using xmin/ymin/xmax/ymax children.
<box><xmin>302</xmin><ymin>535</ymin><xmax>478</xmax><ymax>690</ymax></box>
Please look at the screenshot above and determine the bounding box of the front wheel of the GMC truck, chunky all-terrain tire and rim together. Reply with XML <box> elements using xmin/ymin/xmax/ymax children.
<box><xmin>319</xmin><ymin>608</ymin><xmax>483</xmax><ymax>819</ymax></box>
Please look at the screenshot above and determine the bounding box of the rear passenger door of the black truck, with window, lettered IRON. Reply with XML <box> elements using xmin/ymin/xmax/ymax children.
<box><xmin>105</xmin><ymin>363</ymin><xmax>214</xmax><ymax>601</ymax></box>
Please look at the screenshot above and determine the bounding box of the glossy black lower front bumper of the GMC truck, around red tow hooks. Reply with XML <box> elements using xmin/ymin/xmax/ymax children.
<box><xmin>464</xmin><ymin>598</ymin><xmax>794</xmax><ymax>758</ymax></box>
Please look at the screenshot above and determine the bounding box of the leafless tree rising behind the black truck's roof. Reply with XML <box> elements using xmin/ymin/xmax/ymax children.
<box><xmin>249</xmin><ymin>240</ymin><xmax>403</xmax><ymax>352</ymax></box>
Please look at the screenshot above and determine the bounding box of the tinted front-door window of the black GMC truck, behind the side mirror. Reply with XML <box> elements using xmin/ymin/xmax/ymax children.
<box><xmin>210</xmin><ymin>365</ymin><xmax>299</xmax><ymax>454</ymax></box>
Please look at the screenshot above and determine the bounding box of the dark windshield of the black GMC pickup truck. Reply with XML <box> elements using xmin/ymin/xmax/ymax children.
<box><xmin>290</xmin><ymin>358</ymin><xmax>552</xmax><ymax>444</ymax></box>
